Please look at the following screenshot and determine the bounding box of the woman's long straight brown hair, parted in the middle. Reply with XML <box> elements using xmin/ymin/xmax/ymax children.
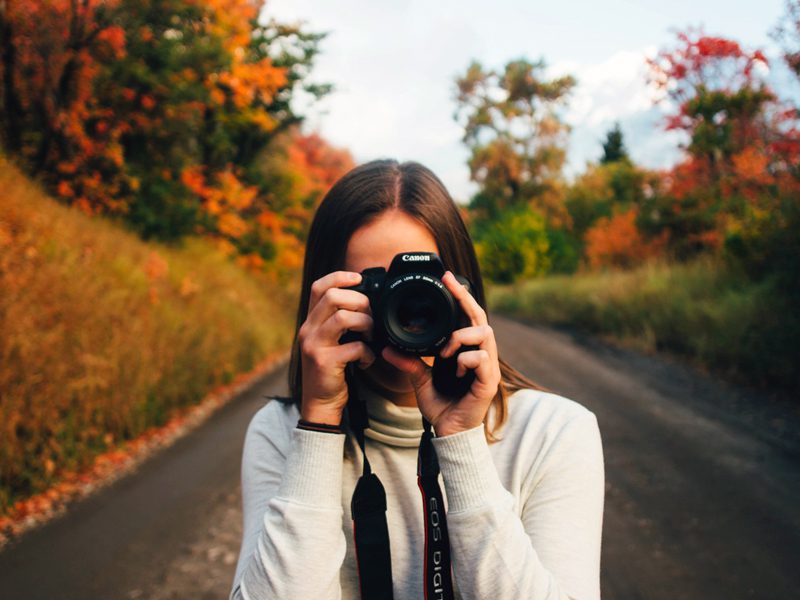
<box><xmin>289</xmin><ymin>159</ymin><xmax>544</xmax><ymax>441</ymax></box>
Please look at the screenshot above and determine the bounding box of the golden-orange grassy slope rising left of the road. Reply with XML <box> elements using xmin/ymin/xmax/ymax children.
<box><xmin>0</xmin><ymin>157</ymin><xmax>295</xmax><ymax>515</ymax></box>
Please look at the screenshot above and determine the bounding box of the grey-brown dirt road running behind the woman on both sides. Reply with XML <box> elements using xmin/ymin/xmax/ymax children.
<box><xmin>0</xmin><ymin>316</ymin><xmax>800</xmax><ymax>600</ymax></box>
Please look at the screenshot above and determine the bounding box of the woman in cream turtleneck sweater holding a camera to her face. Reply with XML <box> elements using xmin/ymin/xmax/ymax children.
<box><xmin>230</xmin><ymin>160</ymin><xmax>604</xmax><ymax>600</ymax></box>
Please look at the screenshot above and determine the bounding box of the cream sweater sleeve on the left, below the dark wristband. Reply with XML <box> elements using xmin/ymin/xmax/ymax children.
<box><xmin>229</xmin><ymin>407</ymin><xmax>346</xmax><ymax>600</ymax></box>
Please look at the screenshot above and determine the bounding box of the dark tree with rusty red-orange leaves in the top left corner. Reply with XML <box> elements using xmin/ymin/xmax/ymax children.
<box><xmin>0</xmin><ymin>0</ymin><xmax>130</xmax><ymax>211</ymax></box>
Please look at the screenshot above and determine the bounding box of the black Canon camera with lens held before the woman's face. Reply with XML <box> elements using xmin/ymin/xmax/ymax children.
<box><xmin>339</xmin><ymin>252</ymin><xmax>477</xmax><ymax>397</ymax></box>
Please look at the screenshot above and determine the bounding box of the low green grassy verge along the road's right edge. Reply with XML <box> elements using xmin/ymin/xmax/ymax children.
<box><xmin>488</xmin><ymin>259</ymin><xmax>800</xmax><ymax>391</ymax></box>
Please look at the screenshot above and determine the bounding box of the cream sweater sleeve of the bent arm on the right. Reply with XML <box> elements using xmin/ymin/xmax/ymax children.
<box><xmin>434</xmin><ymin>411</ymin><xmax>605</xmax><ymax>600</ymax></box>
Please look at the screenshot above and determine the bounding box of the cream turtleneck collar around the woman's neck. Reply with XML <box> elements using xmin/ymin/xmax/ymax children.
<box><xmin>355</xmin><ymin>377</ymin><xmax>423</xmax><ymax>448</ymax></box>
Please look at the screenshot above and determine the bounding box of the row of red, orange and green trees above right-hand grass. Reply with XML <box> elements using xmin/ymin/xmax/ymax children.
<box><xmin>456</xmin><ymin>15</ymin><xmax>800</xmax><ymax>294</ymax></box>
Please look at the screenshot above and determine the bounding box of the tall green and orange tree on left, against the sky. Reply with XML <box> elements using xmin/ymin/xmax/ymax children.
<box><xmin>98</xmin><ymin>0</ymin><xmax>327</xmax><ymax>248</ymax></box>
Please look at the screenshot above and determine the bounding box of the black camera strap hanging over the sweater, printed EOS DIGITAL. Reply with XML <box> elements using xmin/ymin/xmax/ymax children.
<box><xmin>345</xmin><ymin>363</ymin><xmax>454</xmax><ymax>600</ymax></box>
